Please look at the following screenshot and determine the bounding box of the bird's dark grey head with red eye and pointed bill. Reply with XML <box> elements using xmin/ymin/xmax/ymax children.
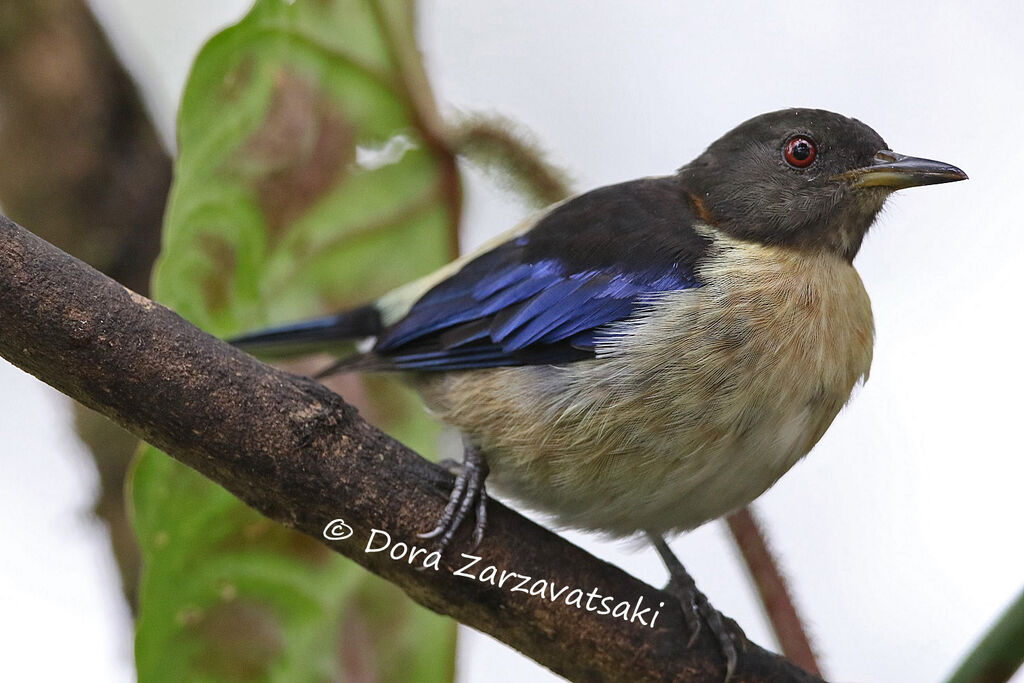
<box><xmin>679</xmin><ymin>109</ymin><xmax>967</xmax><ymax>260</ymax></box>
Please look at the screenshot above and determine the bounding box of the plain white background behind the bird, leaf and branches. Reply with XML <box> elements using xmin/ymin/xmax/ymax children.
<box><xmin>0</xmin><ymin>0</ymin><xmax>1024</xmax><ymax>682</ymax></box>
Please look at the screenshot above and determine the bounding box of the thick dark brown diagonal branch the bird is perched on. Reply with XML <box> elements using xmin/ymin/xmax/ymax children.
<box><xmin>0</xmin><ymin>217</ymin><xmax>819</xmax><ymax>683</ymax></box>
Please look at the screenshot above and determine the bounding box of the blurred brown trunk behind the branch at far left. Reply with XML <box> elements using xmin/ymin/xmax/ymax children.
<box><xmin>0</xmin><ymin>0</ymin><xmax>171</xmax><ymax>610</ymax></box>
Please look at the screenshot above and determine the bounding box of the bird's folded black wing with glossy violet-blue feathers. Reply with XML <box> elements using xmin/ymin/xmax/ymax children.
<box><xmin>366</xmin><ymin>176</ymin><xmax>708</xmax><ymax>371</ymax></box>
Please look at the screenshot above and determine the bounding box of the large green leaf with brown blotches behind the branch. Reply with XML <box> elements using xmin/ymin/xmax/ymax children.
<box><xmin>130</xmin><ymin>0</ymin><xmax>460</xmax><ymax>681</ymax></box>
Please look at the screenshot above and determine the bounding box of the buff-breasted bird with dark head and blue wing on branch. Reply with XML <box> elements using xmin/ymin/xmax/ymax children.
<box><xmin>234</xmin><ymin>109</ymin><xmax>967</xmax><ymax>674</ymax></box>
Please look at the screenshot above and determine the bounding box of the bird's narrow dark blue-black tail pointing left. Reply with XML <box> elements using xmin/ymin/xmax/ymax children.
<box><xmin>227</xmin><ymin>304</ymin><xmax>382</xmax><ymax>357</ymax></box>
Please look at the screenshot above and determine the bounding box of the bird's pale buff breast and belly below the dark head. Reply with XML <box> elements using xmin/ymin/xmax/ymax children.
<box><xmin>417</xmin><ymin>234</ymin><xmax>872</xmax><ymax>536</ymax></box>
